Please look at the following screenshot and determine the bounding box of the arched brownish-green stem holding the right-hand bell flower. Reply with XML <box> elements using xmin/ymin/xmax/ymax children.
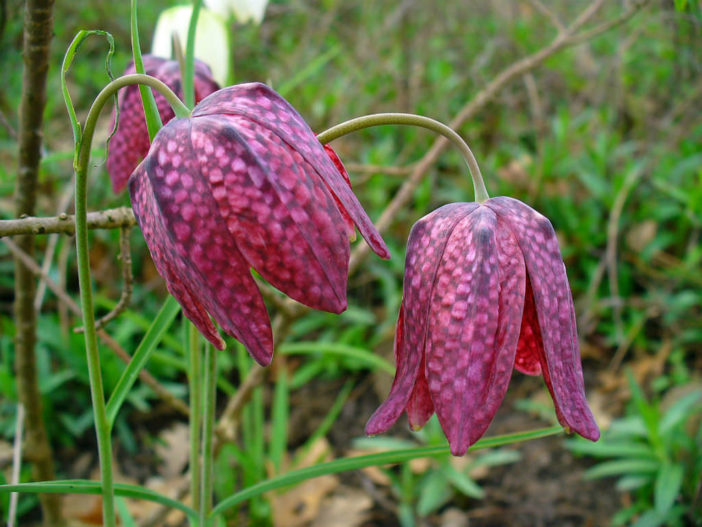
<box><xmin>317</xmin><ymin>113</ymin><xmax>490</xmax><ymax>203</ymax></box>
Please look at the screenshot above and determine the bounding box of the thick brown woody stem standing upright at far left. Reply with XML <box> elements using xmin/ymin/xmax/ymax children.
<box><xmin>14</xmin><ymin>0</ymin><xmax>63</xmax><ymax>526</ymax></box>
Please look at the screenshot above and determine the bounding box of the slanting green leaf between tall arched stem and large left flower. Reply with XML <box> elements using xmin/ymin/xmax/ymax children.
<box><xmin>106</xmin><ymin>295</ymin><xmax>180</xmax><ymax>426</ymax></box>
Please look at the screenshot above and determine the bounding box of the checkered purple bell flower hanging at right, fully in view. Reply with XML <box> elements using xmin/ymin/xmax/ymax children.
<box><xmin>366</xmin><ymin>197</ymin><xmax>600</xmax><ymax>455</ymax></box>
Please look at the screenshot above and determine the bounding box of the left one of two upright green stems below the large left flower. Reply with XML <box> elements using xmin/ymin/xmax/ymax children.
<box><xmin>183</xmin><ymin>317</ymin><xmax>202</xmax><ymax>524</ymax></box>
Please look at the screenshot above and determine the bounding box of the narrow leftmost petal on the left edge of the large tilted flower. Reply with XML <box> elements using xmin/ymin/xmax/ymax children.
<box><xmin>129</xmin><ymin>164</ymin><xmax>224</xmax><ymax>349</ymax></box>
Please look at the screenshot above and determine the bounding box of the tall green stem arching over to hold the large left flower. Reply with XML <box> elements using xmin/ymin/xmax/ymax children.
<box><xmin>75</xmin><ymin>74</ymin><xmax>190</xmax><ymax>527</ymax></box>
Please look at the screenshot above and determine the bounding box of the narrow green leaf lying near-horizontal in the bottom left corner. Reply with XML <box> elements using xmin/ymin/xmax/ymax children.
<box><xmin>0</xmin><ymin>479</ymin><xmax>197</xmax><ymax>519</ymax></box>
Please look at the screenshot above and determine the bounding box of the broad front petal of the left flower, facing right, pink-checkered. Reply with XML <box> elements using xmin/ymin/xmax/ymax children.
<box><xmin>192</xmin><ymin>115</ymin><xmax>349</xmax><ymax>313</ymax></box>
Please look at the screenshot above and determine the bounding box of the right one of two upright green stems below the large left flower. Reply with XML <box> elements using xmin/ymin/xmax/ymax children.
<box><xmin>200</xmin><ymin>343</ymin><xmax>217</xmax><ymax>527</ymax></box>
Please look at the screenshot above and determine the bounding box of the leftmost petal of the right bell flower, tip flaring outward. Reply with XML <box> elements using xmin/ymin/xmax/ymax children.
<box><xmin>366</xmin><ymin>203</ymin><xmax>478</xmax><ymax>435</ymax></box>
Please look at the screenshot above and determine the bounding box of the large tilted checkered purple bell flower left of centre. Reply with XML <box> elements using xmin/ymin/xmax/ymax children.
<box><xmin>129</xmin><ymin>83</ymin><xmax>389</xmax><ymax>365</ymax></box>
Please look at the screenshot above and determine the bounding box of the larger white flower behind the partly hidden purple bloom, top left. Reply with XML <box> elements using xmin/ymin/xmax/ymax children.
<box><xmin>151</xmin><ymin>6</ymin><xmax>231</xmax><ymax>86</ymax></box>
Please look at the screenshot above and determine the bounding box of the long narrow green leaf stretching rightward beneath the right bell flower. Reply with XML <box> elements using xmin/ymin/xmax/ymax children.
<box><xmin>211</xmin><ymin>426</ymin><xmax>563</xmax><ymax>516</ymax></box>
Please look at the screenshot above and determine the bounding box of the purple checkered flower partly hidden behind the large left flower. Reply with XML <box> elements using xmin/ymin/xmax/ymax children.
<box><xmin>107</xmin><ymin>55</ymin><xmax>219</xmax><ymax>192</ymax></box>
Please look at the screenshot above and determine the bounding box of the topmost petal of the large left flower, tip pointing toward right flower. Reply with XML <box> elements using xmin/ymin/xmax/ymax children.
<box><xmin>193</xmin><ymin>83</ymin><xmax>390</xmax><ymax>258</ymax></box>
